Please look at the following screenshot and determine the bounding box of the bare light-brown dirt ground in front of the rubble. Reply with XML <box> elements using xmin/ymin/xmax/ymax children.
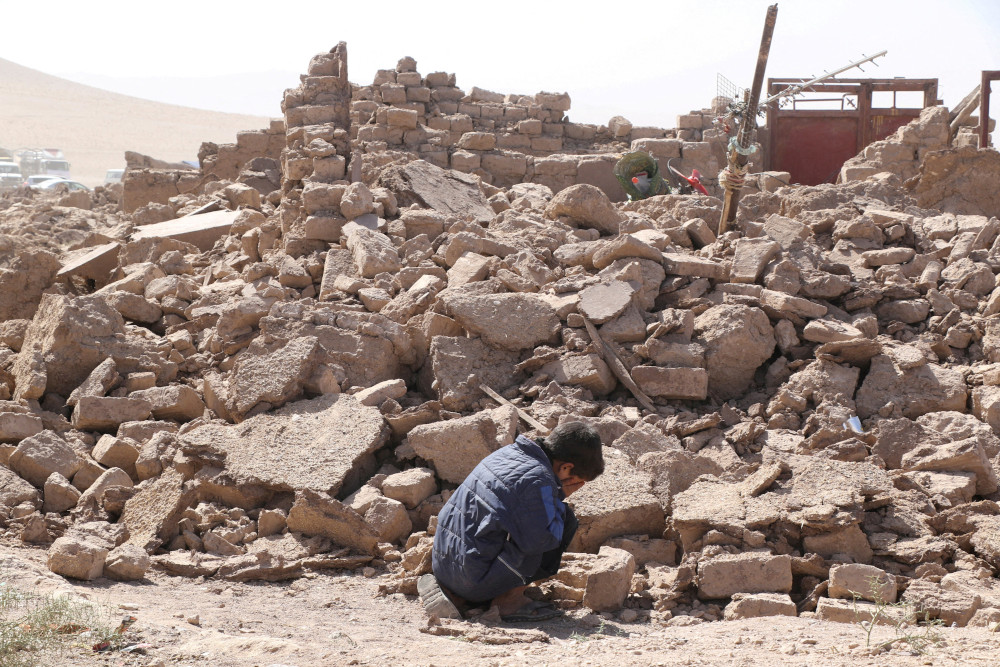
<box><xmin>0</xmin><ymin>540</ymin><xmax>1000</xmax><ymax>667</ymax></box>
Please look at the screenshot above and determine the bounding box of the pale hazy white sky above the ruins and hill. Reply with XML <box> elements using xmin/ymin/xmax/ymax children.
<box><xmin>0</xmin><ymin>0</ymin><xmax>1000</xmax><ymax>132</ymax></box>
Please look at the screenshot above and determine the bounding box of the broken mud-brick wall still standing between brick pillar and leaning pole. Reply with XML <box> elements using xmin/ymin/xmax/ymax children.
<box><xmin>345</xmin><ymin>48</ymin><xmax>752</xmax><ymax>199</ymax></box>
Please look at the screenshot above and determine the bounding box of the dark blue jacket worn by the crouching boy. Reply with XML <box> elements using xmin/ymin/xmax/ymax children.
<box><xmin>432</xmin><ymin>436</ymin><xmax>567</xmax><ymax>602</ymax></box>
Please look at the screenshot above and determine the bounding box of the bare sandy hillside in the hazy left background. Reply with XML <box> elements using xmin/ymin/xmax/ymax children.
<box><xmin>0</xmin><ymin>59</ymin><xmax>268</xmax><ymax>185</ymax></box>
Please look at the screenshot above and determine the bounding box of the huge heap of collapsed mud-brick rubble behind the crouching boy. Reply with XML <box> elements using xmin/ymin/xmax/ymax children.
<box><xmin>0</xmin><ymin>45</ymin><xmax>1000</xmax><ymax>625</ymax></box>
